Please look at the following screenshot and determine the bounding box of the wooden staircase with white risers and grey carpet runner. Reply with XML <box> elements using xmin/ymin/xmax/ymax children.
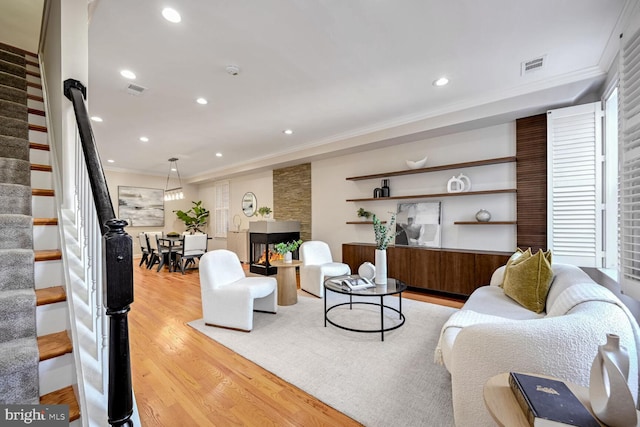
<box><xmin>0</xmin><ymin>43</ymin><xmax>80</xmax><ymax>425</ymax></box>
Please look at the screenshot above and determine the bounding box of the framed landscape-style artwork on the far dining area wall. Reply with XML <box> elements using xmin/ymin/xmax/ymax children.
<box><xmin>118</xmin><ymin>186</ymin><xmax>164</xmax><ymax>227</ymax></box>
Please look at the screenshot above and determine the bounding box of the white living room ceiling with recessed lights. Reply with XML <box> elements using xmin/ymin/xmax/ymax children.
<box><xmin>80</xmin><ymin>0</ymin><xmax>633</xmax><ymax>182</ymax></box>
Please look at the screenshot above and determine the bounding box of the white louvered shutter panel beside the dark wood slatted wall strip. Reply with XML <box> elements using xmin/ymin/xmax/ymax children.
<box><xmin>547</xmin><ymin>102</ymin><xmax>604</xmax><ymax>267</ymax></box>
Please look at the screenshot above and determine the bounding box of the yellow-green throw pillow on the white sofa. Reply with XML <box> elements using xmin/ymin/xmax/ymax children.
<box><xmin>503</xmin><ymin>250</ymin><xmax>553</xmax><ymax>313</ymax></box>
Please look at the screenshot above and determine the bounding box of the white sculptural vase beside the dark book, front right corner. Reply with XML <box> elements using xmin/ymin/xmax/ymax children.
<box><xmin>589</xmin><ymin>334</ymin><xmax>637</xmax><ymax>427</ymax></box>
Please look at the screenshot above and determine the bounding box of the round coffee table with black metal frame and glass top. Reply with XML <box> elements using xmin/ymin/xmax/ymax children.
<box><xmin>324</xmin><ymin>275</ymin><xmax>407</xmax><ymax>341</ymax></box>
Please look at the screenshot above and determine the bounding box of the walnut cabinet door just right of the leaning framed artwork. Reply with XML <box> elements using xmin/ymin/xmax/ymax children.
<box><xmin>440</xmin><ymin>251</ymin><xmax>476</xmax><ymax>295</ymax></box>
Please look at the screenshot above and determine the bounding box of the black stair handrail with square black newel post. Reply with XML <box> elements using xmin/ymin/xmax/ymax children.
<box><xmin>64</xmin><ymin>79</ymin><xmax>133</xmax><ymax>426</ymax></box>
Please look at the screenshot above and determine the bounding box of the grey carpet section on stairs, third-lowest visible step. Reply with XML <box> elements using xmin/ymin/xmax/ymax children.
<box><xmin>0</xmin><ymin>249</ymin><xmax>35</xmax><ymax>290</ymax></box>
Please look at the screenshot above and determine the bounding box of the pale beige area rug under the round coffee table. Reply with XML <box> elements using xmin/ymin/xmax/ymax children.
<box><xmin>189</xmin><ymin>291</ymin><xmax>456</xmax><ymax>427</ymax></box>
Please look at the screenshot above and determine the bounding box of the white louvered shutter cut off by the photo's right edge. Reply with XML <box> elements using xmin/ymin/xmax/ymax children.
<box><xmin>618</xmin><ymin>22</ymin><xmax>640</xmax><ymax>299</ymax></box>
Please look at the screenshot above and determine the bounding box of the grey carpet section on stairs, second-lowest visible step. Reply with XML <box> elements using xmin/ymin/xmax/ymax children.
<box><xmin>0</xmin><ymin>289</ymin><xmax>36</xmax><ymax>343</ymax></box>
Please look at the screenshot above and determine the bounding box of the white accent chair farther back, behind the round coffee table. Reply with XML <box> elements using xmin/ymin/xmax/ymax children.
<box><xmin>300</xmin><ymin>240</ymin><xmax>351</xmax><ymax>298</ymax></box>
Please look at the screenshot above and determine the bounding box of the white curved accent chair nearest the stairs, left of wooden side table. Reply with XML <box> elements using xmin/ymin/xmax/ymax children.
<box><xmin>200</xmin><ymin>249</ymin><xmax>278</xmax><ymax>332</ymax></box>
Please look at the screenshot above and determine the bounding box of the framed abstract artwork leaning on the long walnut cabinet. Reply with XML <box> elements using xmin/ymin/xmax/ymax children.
<box><xmin>396</xmin><ymin>202</ymin><xmax>442</xmax><ymax>248</ymax></box>
